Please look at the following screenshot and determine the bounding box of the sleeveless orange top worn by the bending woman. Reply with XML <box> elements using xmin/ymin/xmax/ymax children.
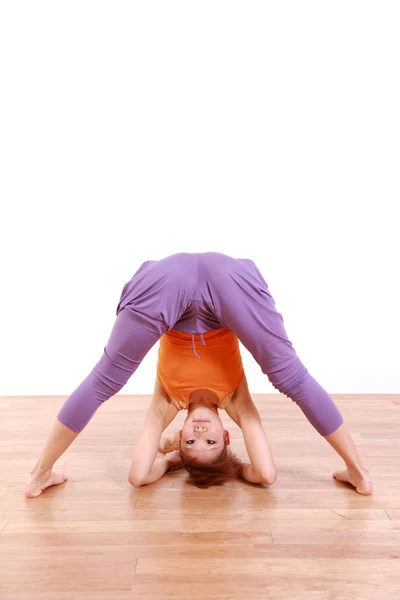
<box><xmin>157</xmin><ymin>329</ymin><xmax>244</xmax><ymax>410</ymax></box>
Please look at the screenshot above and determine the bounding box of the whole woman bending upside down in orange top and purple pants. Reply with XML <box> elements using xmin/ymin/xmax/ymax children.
<box><xmin>25</xmin><ymin>252</ymin><xmax>372</xmax><ymax>497</ymax></box>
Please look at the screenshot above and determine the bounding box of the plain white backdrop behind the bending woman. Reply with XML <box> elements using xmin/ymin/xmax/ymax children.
<box><xmin>0</xmin><ymin>0</ymin><xmax>400</xmax><ymax>395</ymax></box>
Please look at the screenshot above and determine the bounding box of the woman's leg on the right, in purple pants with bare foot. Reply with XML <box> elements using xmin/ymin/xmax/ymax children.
<box><xmin>201</xmin><ymin>253</ymin><xmax>374</xmax><ymax>489</ymax></box>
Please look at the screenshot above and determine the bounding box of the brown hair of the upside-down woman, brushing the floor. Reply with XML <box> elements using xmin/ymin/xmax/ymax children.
<box><xmin>159</xmin><ymin>434</ymin><xmax>241</xmax><ymax>488</ymax></box>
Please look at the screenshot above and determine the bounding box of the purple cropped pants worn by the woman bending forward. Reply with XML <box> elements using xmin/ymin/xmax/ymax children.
<box><xmin>58</xmin><ymin>252</ymin><xmax>343</xmax><ymax>436</ymax></box>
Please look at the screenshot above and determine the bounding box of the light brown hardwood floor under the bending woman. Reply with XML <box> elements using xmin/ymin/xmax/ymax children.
<box><xmin>0</xmin><ymin>395</ymin><xmax>400</xmax><ymax>600</ymax></box>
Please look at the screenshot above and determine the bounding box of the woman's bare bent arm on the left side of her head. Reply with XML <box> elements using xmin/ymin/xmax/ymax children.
<box><xmin>129</xmin><ymin>378</ymin><xmax>178</xmax><ymax>487</ymax></box>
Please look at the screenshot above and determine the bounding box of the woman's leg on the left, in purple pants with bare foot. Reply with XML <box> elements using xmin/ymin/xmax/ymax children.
<box><xmin>26</xmin><ymin>255</ymin><xmax>192</xmax><ymax>497</ymax></box>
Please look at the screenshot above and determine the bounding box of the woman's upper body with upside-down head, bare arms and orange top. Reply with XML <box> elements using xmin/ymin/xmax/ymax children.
<box><xmin>129</xmin><ymin>329</ymin><xmax>276</xmax><ymax>487</ymax></box>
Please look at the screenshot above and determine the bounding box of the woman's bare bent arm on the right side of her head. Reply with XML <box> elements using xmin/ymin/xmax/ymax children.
<box><xmin>226</xmin><ymin>377</ymin><xmax>276</xmax><ymax>485</ymax></box>
